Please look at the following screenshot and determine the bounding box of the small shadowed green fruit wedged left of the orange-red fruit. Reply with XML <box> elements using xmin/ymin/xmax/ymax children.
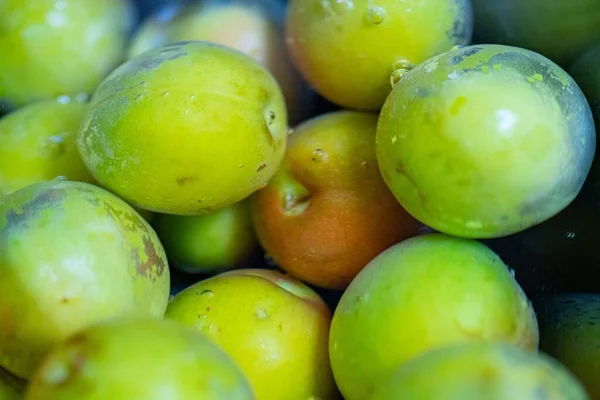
<box><xmin>155</xmin><ymin>200</ymin><xmax>258</xmax><ymax>273</ymax></box>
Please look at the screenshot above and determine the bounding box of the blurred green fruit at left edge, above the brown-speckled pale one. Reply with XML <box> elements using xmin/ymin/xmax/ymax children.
<box><xmin>0</xmin><ymin>96</ymin><xmax>93</xmax><ymax>196</ymax></box>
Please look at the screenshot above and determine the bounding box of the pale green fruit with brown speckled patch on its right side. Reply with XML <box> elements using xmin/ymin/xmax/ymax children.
<box><xmin>0</xmin><ymin>181</ymin><xmax>169</xmax><ymax>377</ymax></box>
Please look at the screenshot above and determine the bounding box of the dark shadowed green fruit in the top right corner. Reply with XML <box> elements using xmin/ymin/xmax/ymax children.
<box><xmin>473</xmin><ymin>0</ymin><xmax>600</xmax><ymax>66</ymax></box>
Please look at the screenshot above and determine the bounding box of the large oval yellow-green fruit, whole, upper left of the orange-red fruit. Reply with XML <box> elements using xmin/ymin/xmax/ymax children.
<box><xmin>77</xmin><ymin>42</ymin><xmax>287</xmax><ymax>215</ymax></box>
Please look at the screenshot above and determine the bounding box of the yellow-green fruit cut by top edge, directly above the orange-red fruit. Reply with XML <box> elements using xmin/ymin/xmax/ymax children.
<box><xmin>286</xmin><ymin>0</ymin><xmax>473</xmax><ymax>110</ymax></box>
